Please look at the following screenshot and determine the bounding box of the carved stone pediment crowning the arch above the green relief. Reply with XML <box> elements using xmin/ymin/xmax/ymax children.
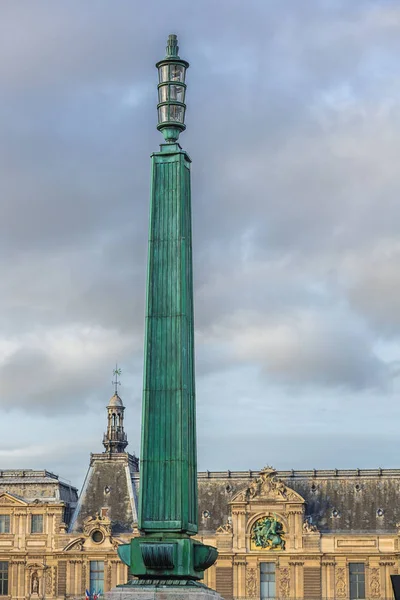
<box><xmin>231</xmin><ymin>467</ymin><xmax>304</xmax><ymax>504</ymax></box>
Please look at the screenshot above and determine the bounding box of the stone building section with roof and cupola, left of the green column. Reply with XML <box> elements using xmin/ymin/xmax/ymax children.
<box><xmin>0</xmin><ymin>394</ymin><xmax>138</xmax><ymax>600</ymax></box>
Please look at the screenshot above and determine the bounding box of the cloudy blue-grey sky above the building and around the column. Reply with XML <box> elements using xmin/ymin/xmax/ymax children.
<box><xmin>0</xmin><ymin>0</ymin><xmax>400</xmax><ymax>487</ymax></box>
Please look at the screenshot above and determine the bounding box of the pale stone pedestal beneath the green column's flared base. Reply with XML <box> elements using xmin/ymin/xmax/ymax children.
<box><xmin>104</xmin><ymin>582</ymin><xmax>223</xmax><ymax>600</ymax></box>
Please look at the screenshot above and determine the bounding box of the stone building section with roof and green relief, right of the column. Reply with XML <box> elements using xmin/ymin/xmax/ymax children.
<box><xmin>198</xmin><ymin>467</ymin><xmax>400</xmax><ymax>600</ymax></box>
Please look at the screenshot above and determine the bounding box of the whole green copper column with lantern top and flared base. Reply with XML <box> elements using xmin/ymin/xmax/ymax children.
<box><xmin>119</xmin><ymin>35</ymin><xmax>217</xmax><ymax>581</ymax></box>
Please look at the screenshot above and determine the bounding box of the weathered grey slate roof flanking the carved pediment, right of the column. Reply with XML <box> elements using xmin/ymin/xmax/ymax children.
<box><xmin>198</xmin><ymin>469</ymin><xmax>400</xmax><ymax>534</ymax></box>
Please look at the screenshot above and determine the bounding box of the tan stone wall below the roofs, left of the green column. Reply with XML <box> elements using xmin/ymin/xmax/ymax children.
<box><xmin>0</xmin><ymin>493</ymin><xmax>129</xmax><ymax>600</ymax></box>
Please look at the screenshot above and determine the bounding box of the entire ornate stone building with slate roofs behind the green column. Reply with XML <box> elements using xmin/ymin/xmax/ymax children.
<box><xmin>0</xmin><ymin>394</ymin><xmax>400</xmax><ymax>600</ymax></box>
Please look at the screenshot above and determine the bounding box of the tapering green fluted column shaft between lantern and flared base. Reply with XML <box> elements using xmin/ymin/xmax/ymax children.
<box><xmin>139</xmin><ymin>144</ymin><xmax>197</xmax><ymax>535</ymax></box>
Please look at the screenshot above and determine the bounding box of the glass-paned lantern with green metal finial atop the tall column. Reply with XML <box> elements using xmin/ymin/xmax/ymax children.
<box><xmin>156</xmin><ymin>34</ymin><xmax>189</xmax><ymax>143</ymax></box>
